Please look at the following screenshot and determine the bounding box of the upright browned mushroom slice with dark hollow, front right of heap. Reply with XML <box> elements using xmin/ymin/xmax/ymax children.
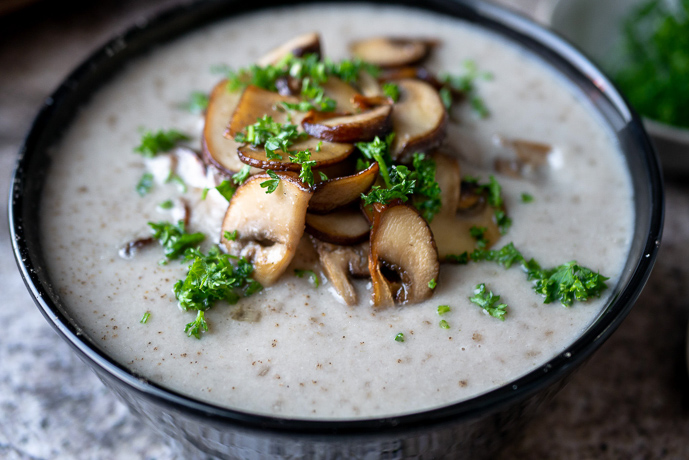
<box><xmin>368</xmin><ymin>202</ymin><xmax>440</xmax><ymax>306</ymax></box>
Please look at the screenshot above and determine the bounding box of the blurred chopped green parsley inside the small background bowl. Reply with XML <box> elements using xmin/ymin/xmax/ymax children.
<box><xmin>612</xmin><ymin>0</ymin><xmax>689</xmax><ymax>128</ymax></box>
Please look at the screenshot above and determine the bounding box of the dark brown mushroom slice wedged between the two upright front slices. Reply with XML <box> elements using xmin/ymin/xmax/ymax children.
<box><xmin>306</xmin><ymin>208</ymin><xmax>370</xmax><ymax>245</ymax></box>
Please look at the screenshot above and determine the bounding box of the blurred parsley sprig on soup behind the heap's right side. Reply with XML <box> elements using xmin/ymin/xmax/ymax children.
<box><xmin>438</xmin><ymin>60</ymin><xmax>493</xmax><ymax>118</ymax></box>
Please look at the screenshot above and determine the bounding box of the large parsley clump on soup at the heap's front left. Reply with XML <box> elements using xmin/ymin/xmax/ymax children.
<box><xmin>173</xmin><ymin>246</ymin><xmax>263</xmax><ymax>339</ymax></box>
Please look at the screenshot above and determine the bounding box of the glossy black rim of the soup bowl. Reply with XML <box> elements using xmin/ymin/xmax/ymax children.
<box><xmin>9</xmin><ymin>0</ymin><xmax>664</xmax><ymax>435</ymax></box>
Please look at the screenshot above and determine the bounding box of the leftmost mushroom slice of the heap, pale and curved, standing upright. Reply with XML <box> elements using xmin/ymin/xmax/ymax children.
<box><xmin>202</xmin><ymin>80</ymin><xmax>259</xmax><ymax>175</ymax></box>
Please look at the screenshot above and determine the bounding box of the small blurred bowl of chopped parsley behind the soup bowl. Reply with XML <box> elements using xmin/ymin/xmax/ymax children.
<box><xmin>550</xmin><ymin>0</ymin><xmax>689</xmax><ymax>174</ymax></box>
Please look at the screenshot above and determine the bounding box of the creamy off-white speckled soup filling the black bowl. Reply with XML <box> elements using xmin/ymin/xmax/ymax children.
<box><xmin>41</xmin><ymin>5</ymin><xmax>633</xmax><ymax>419</ymax></box>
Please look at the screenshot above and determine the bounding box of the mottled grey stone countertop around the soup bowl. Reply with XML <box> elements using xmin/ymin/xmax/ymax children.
<box><xmin>0</xmin><ymin>0</ymin><xmax>689</xmax><ymax>460</ymax></box>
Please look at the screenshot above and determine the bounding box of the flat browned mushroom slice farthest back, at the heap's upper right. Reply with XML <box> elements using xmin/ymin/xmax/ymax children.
<box><xmin>349</xmin><ymin>37</ymin><xmax>431</xmax><ymax>67</ymax></box>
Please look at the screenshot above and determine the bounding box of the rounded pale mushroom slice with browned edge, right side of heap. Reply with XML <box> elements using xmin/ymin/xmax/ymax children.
<box><xmin>391</xmin><ymin>79</ymin><xmax>447</xmax><ymax>160</ymax></box>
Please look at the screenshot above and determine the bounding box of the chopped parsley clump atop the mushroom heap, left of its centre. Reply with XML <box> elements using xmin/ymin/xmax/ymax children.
<box><xmin>234</xmin><ymin>115</ymin><xmax>308</xmax><ymax>160</ymax></box>
